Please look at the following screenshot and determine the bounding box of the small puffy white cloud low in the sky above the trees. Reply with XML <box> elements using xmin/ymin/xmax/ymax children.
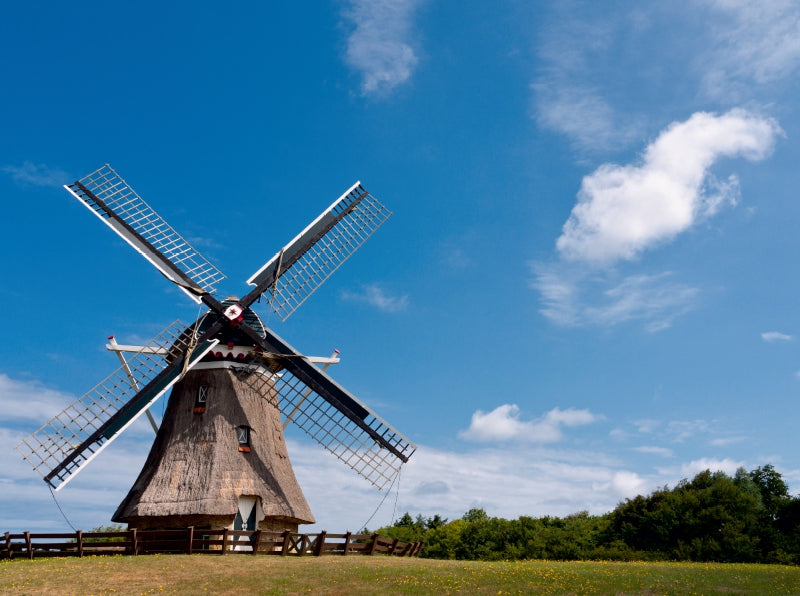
<box><xmin>459</xmin><ymin>404</ymin><xmax>598</xmax><ymax>443</ymax></box>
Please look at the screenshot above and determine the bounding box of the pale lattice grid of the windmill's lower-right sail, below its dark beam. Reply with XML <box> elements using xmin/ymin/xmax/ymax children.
<box><xmin>240</xmin><ymin>366</ymin><xmax>416</xmax><ymax>490</ymax></box>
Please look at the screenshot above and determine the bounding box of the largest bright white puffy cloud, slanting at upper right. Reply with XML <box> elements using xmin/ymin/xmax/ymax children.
<box><xmin>556</xmin><ymin>109</ymin><xmax>781</xmax><ymax>264</ymax></box>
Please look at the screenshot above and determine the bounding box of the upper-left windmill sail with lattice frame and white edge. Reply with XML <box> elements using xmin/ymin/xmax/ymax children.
<box><xmin>64</xmin><ymin>164</ymin><xmax>225</xmax><ymax>303</ymax></box>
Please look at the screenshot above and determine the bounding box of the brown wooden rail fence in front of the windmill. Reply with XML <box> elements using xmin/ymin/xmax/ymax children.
<box><xmin>0</xmin><ymin>528</ymin><xmax>423</xmax><ymax>559</ymax></box>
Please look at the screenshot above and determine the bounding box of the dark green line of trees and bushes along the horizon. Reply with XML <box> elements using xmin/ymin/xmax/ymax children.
<box><xmin>377</xmin><ymin>465</ymin><xmax>800</xmax><ymax>564</ymax></box>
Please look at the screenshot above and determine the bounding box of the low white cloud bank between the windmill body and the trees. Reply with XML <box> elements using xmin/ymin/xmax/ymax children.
<box><xmin>289</xmin><ymin>444</ymin><xmax>648</xmax><ymax>531</ymax></box>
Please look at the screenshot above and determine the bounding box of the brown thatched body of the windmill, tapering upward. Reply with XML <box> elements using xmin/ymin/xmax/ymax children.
<box><xmin>112</xmin><ymin>368</ymin><xmax>315</xmax><ymax>530</ymax></box>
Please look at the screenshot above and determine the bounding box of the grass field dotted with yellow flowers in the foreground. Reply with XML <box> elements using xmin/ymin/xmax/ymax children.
<box><xmin>0</xmin><ymin>555</ymin><xmax>800</xmax><ymax>595</ymax></box>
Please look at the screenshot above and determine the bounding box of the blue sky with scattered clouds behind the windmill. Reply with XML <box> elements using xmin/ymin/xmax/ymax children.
<box><xmin>0</xmin><ymin>0</ymin><xmax>800</xmax><ymax>531</ymax></box>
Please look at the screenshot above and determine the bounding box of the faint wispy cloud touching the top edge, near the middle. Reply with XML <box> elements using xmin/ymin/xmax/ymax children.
<box><xmin>344</xmin><ymin>0</ymin><xmax>420</xmax><ymax>95</ymax></box>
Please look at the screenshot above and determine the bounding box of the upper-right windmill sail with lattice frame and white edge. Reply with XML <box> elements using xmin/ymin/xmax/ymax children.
<box><xmin>247</xmin><ymin>182</ymin><xmax>391</xmax><ymax>321</ymax></box>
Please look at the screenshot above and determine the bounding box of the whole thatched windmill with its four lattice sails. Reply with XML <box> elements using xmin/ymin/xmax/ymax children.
<box><xmin>16</xmin><ymin>164</ymin><xmax>416</xmax><ymax>531</ymax></box>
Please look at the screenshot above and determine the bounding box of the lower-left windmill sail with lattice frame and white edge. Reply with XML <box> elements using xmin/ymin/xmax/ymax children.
<box><xmin>15</xmin><ymin>321</ymin><xmax>219</xmax><ymax>490</ymax></box>
